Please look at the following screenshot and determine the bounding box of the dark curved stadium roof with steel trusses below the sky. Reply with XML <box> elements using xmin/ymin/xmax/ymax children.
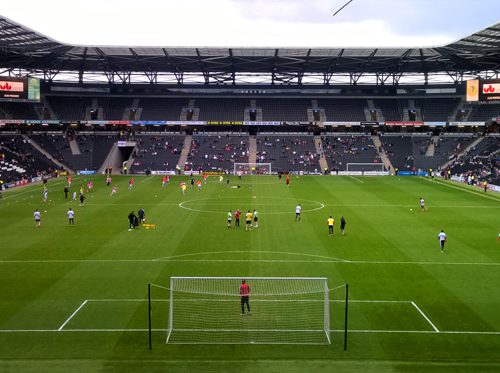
<box><xmin>0</xmin><ymin>17</ymin><xmax>500</xmax><ymax>84</ymax></box>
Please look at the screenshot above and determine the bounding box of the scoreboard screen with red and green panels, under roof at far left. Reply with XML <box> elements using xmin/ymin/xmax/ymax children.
<box><xmin>0</xmin><ymin>76</ymin><xmax>40</xmax><ymax>102</ymax></box>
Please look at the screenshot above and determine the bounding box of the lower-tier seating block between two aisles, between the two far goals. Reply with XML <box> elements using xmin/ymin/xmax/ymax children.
<box><xmin>257</xmin><ymin>133</ymin><xmax>321</xmax><ymax>173</ymax></box>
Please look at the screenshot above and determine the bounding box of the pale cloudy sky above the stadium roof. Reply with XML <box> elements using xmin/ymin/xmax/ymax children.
<box><xmin>0</xmin><ymin>0</ymin><xmax>500</xmax><ymax>47</ymax></box>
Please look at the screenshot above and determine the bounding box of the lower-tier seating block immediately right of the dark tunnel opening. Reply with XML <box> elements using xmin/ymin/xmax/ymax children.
<box><xmin>130</xmin><ymin>133</ymin><xmax>185</xmax><ymax>173</ymax></box>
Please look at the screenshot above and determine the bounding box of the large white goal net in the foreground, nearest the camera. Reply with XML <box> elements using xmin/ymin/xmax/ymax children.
<box><xmin>167</xmin><ymin>277</ymin><xmax>331</xmax><ymax>344</ymax></box>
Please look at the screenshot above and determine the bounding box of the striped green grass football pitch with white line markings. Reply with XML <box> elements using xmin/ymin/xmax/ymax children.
<box><xmin>0</xmin><ymin>175</ymin><xmax>500</xmax><ymax>373</ymax></box>
